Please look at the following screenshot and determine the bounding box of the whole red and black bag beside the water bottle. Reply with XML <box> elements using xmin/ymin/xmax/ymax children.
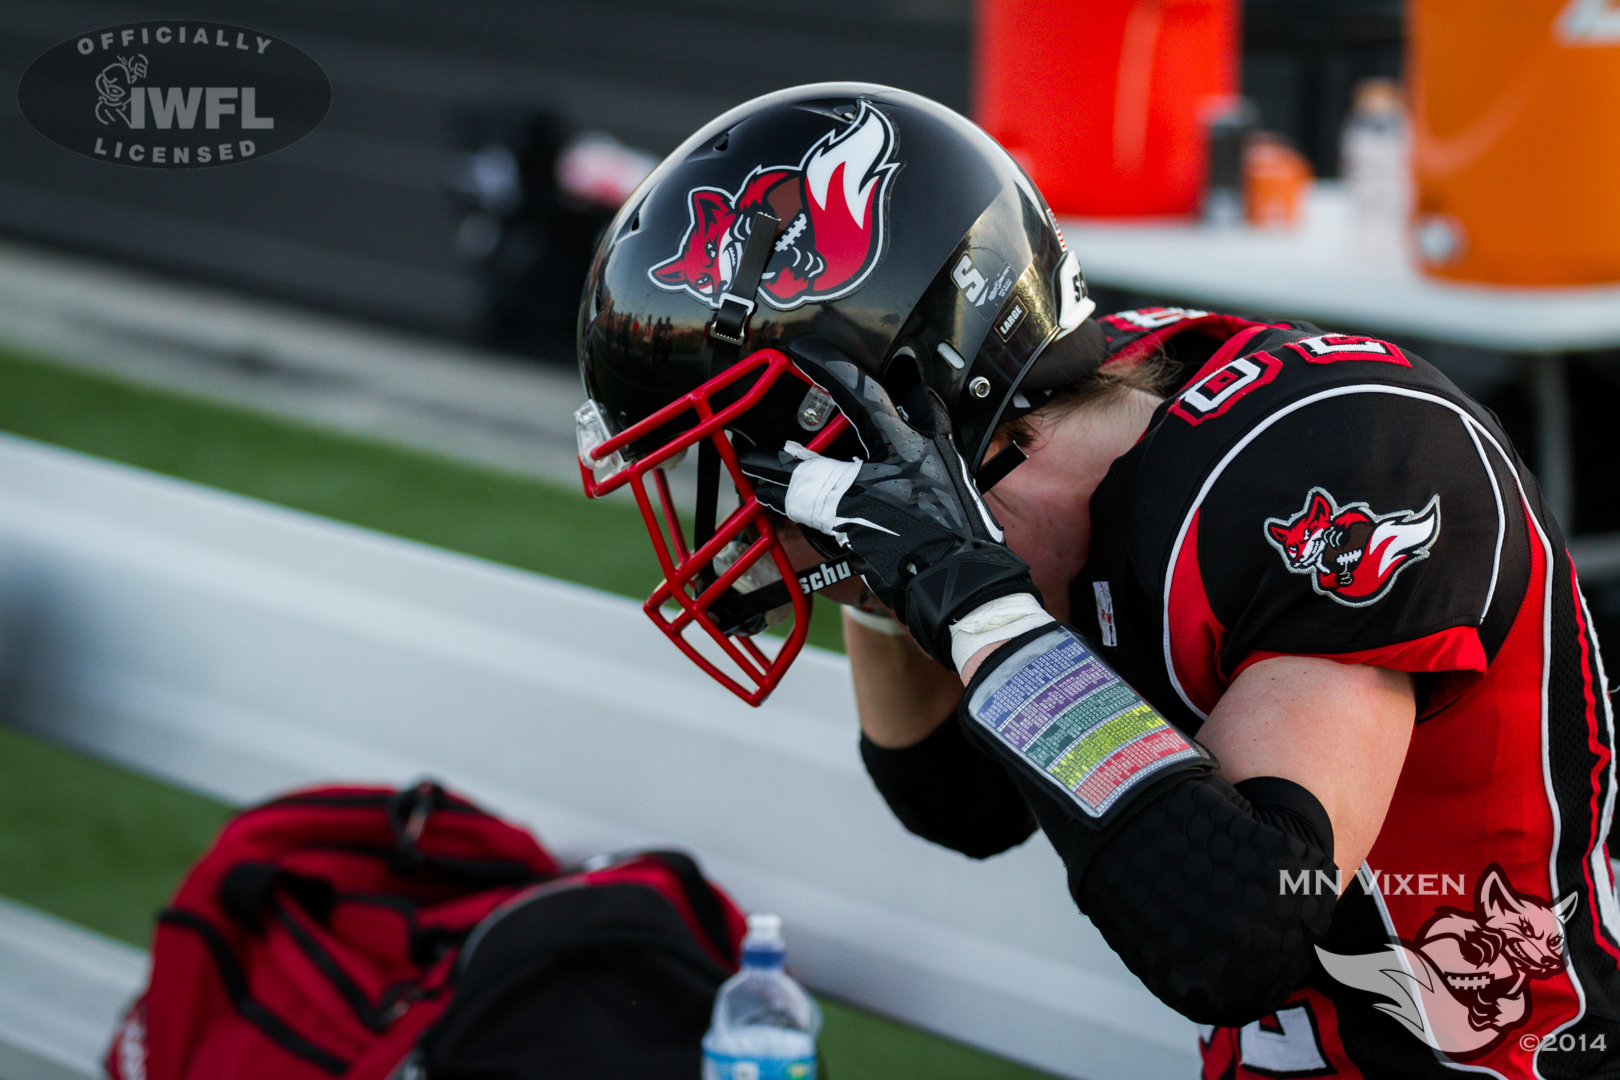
<box><xmin>105</xmin><ymin>784</ymin><xmax>744</xmax><ymax>1080</ymax></box>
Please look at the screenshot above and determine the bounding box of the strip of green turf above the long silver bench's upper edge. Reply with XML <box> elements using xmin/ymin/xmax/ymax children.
<box><xmin>0</xmin><ymin>350</ymin><xmax>844</xmax><ymax>651</ymax></box>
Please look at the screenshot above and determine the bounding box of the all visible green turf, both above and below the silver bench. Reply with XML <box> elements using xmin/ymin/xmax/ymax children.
<box><xmin>0</xmin><ymin>350</ymin><xmax>1045</xmax><ymax>1080</ymax></box>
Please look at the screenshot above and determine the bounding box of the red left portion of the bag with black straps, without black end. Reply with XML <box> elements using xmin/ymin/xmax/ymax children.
<box><xmin>107</xmin><ymin>784</ymin><xmax>557</xmax><ymax>1080</ymax></box>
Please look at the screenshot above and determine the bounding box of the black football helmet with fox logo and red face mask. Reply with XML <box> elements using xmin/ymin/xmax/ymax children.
<box><xmin>577</xmin><ymin>83</ymin><xmax>1100</xmax><ymax>704</ymax></box>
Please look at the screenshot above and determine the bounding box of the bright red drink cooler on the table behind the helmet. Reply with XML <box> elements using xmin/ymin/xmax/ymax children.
<box><xmin>974</xmin><ymin>0</ymin><xmax>1238</xmax><ymax>217</ymax></box>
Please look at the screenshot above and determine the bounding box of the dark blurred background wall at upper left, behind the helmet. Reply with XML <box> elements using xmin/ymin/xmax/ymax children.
<box><xmin>0</xmin><ymin>0</ymin><xmax>972</xmax><ymax>335</ymax></box>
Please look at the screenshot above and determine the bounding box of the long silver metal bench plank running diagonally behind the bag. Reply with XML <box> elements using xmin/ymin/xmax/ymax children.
<box><xmin>0</xmin><ymin>437</ymin><xmax>1197</xmax><ymax>1080</ymax></box>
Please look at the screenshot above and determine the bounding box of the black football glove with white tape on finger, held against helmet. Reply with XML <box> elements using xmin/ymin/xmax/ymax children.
<box><xmin>740</xmin><ymin>337</ymin><xmax>1038</xmax><ymax>670</ymax></box>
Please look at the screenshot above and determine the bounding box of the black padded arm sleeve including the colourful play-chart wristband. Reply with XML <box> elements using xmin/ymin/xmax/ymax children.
<box><xmin>961</xmin><ymin>623</ymin><xmax>1338</xmax><ymax>1027</ymax></box>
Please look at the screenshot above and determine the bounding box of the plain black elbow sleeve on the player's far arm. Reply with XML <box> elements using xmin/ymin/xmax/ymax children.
<box><xmin>860</xmin><ymin>719</ymin><xmax>1035</xmax><ymax>858</ymax></box>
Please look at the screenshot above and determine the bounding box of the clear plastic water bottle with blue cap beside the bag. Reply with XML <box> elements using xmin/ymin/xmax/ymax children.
<box><xmin>703</xmin><ymin>915</ymin><xmax>821</xmax><ymax>1080</ymax></box>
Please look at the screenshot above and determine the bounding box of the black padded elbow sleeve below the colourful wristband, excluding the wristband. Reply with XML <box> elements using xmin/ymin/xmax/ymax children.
<box><xmin>1021</xmin><ymin>774</ymin><xmax>1338</xmax><ymax>1027</ymax></box>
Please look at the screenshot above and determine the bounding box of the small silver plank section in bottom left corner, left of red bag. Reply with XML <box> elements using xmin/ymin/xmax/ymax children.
<box><xmin>0</xmin><ymin>899</ymin><xmax>146</xmax><ymax>1080</ymax></box>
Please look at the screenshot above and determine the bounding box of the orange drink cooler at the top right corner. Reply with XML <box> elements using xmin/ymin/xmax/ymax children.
<box><xmin>1409</xmin><ymin>0</ymin><xmax>1620</xmax><ymax>285</ymax></box>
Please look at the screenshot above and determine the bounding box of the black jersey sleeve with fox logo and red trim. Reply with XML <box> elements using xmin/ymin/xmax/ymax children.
<box><xmin>1166</xmin><ymin>393</ymin><xmax>1528</xmax><ymax>696</ymax></box>
